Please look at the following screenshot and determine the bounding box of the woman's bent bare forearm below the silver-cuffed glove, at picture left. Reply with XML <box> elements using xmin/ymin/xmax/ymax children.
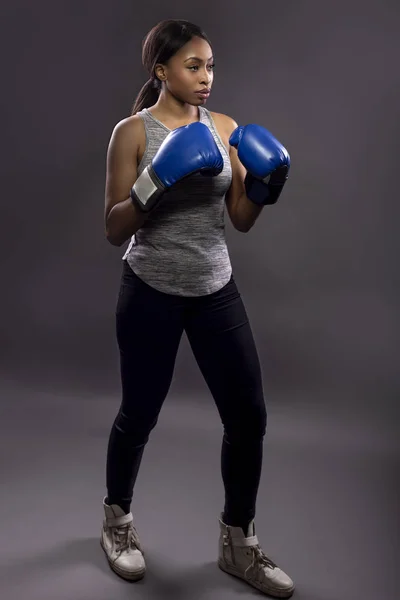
<box><xmin>106</xmin><ymin>198</ymin><xmax>149</xmax><ymax>246</ymax></box>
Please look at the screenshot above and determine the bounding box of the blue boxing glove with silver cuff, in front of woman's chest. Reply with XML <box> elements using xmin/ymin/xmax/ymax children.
<box><xmin>130</xmin><ymin>121</ymin><xmax>224</xmax><ymax>212</ymax></box>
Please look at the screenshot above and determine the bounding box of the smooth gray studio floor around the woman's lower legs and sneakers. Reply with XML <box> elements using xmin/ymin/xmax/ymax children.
<box><xmin>0</xmin><ymin>385</ymin><xmax>400</xmax><ymax>600</ymax></box>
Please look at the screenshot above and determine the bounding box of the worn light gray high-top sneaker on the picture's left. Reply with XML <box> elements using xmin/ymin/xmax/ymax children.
<box><xmin>100</xmin><ymin>496</ymin><xmax>146</xmax><ymax>581</ymax></box>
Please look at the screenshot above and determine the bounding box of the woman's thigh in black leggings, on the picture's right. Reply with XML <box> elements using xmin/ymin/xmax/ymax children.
<box><xmin>185</xmin><ymin>278</ymin><xmax>266</xmax><ymax>429</ymax></box>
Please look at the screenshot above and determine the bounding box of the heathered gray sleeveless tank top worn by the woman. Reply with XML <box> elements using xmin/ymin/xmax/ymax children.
<box><xmin>123</xmin><ymin>106</ymin><xmax>232</xmax><ymax>296</ymax></box>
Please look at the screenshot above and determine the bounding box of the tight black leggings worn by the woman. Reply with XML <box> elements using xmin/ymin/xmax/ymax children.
<box><xmin>107</xmin><ymin>261</ymin><xmax>267</xmax><ymax>527</ymax></box>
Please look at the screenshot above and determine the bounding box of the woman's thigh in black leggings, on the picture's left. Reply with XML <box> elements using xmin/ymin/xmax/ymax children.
<box><xmin>116</xmin><ymin>261</ymin><xmax>183</xmax><ymax>418</ymax></box>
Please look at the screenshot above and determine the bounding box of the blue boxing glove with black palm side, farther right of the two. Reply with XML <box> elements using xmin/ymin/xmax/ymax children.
<box><xmin>229</xmin><ymin>125</ymin><xmax>290</xmax><ymax>206</ymax></box>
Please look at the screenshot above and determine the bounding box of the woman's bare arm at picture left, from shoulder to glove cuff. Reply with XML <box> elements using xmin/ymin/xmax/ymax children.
<box><xmin>104</xmin><ymin>117</ymin><xmax>148</xmax><ymax>246</ymax></box>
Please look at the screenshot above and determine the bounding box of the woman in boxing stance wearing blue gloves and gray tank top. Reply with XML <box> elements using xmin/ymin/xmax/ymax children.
<box><xmin>101</xmin><ymin>20</ymin><xmax>294</xmax><ymax>598</ymax></box>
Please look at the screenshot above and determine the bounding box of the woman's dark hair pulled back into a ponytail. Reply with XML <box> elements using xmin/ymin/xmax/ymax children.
<box><xmin>131</xmin><ymin>19</ymin><xmax>211</xmax><ymax>115</ymax></box>
